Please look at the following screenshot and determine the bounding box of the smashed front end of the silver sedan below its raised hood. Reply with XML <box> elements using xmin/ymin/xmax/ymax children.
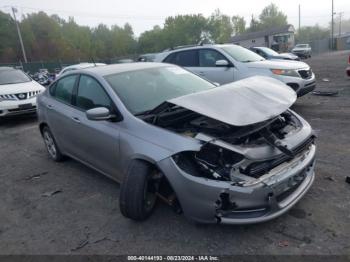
<box><xmin>153</xmin><ymin>110</ymin><xmax>316</xmax><ymax>224</ymax></box>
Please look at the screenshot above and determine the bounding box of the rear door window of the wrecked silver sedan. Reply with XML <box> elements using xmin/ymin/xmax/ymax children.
<box><xmin>51</xmin><ymin>75</ymin><xmax>78</xmax><ymax>104</ymax></box>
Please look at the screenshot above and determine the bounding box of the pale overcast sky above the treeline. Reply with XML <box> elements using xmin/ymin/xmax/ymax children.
<box><xmin>0</xmin><ymin>0</ymin><xmax>350</xmax><ymax>36</ymax></box>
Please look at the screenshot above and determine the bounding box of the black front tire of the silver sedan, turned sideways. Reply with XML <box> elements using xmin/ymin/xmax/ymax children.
<box><xmin>119</xmin><ymin>160</ymin><xmax>160</xmax><ymax>221</ymax></box>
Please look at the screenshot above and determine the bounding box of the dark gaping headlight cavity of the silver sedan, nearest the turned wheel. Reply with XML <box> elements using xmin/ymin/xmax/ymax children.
<box><xmin>173</xmin><ymin>144</ymin><xmax>244</xmax><ymax>181</ymax></box>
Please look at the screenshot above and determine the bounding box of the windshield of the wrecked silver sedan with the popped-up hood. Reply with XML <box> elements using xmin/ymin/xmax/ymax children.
<box><xmin>105</xmin><ymin>66</ymin><xmax>215</xmax><ymax>114</ymax></box>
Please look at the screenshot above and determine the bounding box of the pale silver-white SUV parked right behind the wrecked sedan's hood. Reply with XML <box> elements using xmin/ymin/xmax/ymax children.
<box><xmin>155</xmin><ymin>44</ymin><xmax>316</xmax><ymax>96</ymax></box>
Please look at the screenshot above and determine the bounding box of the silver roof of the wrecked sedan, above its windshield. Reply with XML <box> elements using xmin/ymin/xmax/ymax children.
<box><xmin>83</xmin><ymin>62</ymin><xmax>170</xmax><ymax>76</ymax></box>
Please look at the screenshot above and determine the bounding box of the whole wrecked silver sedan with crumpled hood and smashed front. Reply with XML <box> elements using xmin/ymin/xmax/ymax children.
<box><xmin>38</xmin><ymin>63</ymin><xmax>316</xmax><ymax>224</ymax></box>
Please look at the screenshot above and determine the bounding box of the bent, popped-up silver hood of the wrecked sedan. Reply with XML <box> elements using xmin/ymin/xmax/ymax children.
<box><xmin>167</xmin><ymin>76</ymin><xmax>297</xmax><ymax>126</ymax></box>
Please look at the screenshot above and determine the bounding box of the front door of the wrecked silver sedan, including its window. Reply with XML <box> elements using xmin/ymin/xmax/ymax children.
<box><xmin>72</xmin><ymin>75</ymin><xmax>119</xmax><ymax>178</ymax></box>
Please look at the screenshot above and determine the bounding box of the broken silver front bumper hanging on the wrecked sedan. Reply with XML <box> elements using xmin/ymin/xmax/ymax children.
<box><xmin>158</xmin><ymin>145</ymin><xmax>316</xmax><ymax>224</ymax></box>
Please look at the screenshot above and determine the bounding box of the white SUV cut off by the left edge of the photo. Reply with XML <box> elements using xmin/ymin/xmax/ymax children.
<box><xmin>0</xmin><ymin>67</ymin><xmax>45</xmax><ymax>117</ymax></box>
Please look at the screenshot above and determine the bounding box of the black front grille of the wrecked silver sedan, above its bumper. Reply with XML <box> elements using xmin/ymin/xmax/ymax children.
<box><xmin>241</xmin><ymin>136</ymin><xmax>315</xmax><ymax>178</ymax></box>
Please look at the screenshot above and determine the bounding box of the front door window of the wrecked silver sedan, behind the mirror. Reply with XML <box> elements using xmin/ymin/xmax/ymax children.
<box><xmin>76</xmin><ymin>75</ymin><xmax>112</xmax><ymax>110</ymax></box>
